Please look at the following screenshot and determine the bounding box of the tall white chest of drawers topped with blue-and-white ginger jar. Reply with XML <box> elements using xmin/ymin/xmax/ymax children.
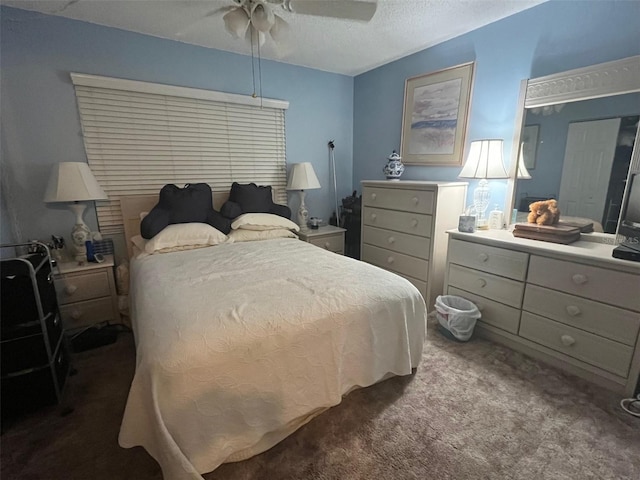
<box><xmin>361</xmin><ymin>180</ymin><xmax>467</xmax><ymax>308</ymax></box>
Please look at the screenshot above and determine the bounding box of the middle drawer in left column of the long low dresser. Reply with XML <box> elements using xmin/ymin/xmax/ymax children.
<box><xmin>449</xmin><ymin>264</ymin><xmax>524</xmax><ymax>308</ymax></box>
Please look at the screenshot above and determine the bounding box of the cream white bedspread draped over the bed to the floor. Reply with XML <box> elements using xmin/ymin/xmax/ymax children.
<box><xmin>119</xmin><ymin>239</ymin><xmax>426</xmax><ymax>480</ymax></box>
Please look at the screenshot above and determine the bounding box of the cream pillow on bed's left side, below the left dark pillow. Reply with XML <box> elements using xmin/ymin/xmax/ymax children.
<box><xmin>144</xmin><ymin>223</ymin><xmax>228</xmax><ymax>253</ymax></box>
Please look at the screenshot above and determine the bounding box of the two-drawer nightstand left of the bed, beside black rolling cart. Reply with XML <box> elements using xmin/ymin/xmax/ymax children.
<box><xmin>55</xmin><ymin>255</ymin><xmax>122</xmax><ymax>333</ymax></box>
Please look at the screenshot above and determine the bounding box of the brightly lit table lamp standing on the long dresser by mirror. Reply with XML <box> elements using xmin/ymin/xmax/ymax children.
<box><xmin>458</xmin><ymin>139</ymin><xmax>509</xmax><ymax>230</ymax></box>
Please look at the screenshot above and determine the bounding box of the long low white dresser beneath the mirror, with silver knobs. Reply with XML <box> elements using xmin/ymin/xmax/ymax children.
<box><xmin>446</xmin><ymin>230</ymin><xmax>640</xmax><ymax>396</ymax></box>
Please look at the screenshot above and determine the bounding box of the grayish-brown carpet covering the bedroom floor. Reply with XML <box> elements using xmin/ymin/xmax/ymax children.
<box><xmin>0</xmin><ymin>328</ymin><xmax>640</xmax><ymax>480</ymax></box>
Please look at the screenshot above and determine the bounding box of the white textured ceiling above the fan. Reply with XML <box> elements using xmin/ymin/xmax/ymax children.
<box><xmin>0</xmin><ymin>0</ymin><xmax>546</xmax><ymax>75</ymax></box>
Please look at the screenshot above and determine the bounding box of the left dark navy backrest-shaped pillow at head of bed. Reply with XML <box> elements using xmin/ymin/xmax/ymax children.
<box><xmin>140</xmin><ymin>183</ymin><xmax>231</xmax><ymax>239</ymax></box>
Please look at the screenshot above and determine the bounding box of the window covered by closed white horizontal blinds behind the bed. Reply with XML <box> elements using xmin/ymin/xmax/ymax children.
<box><xmin>71</xmin><ymin>74</ymin><xmax>288</xmax><ymax>234</ymax></box>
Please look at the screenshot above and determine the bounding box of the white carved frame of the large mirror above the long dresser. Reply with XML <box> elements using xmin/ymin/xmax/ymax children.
<box><xmin>505</xmin><ymin>55</ymin><xmax>640</xmax><ymax>236</ymax></box>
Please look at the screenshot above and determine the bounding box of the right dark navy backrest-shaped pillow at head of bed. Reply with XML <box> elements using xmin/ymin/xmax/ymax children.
<box><xmin>220</xmin><ymin>182</ymin><xmax>291</xmax><ymax>219</ymax></box>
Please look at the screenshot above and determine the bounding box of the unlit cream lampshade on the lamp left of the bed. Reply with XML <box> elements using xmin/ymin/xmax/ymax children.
<box><xmin>44</xmin><ymin>162</ymin><xmax>107</xmax><ymax>203</ymax></box>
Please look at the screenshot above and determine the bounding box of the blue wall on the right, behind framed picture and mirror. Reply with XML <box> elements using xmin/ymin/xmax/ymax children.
<box><xmin>353</xmin><ymin>0</ymin><xmax>640</xmax><ymax>212</ymax></box>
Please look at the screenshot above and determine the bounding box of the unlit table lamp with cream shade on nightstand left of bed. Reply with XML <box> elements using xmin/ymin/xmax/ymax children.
<box><xmin>44</xmin><ymin>162</ymin><xmax>107</xmax><ymax>261</ymax></box>
